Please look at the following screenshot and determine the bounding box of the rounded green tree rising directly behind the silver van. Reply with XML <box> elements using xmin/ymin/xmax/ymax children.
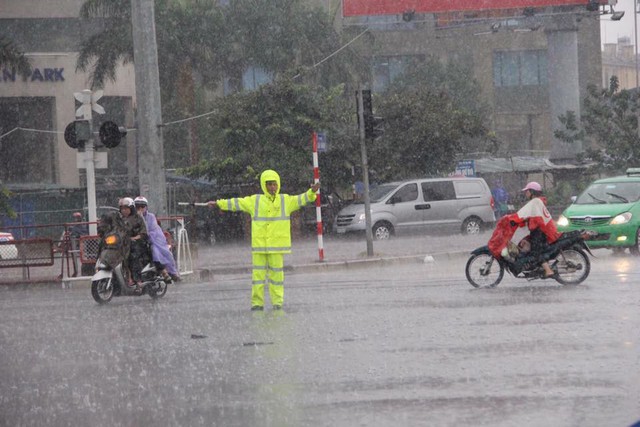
<box><xmin>369</xmin><ymin>58</ymin><xmax>496</xmax><ymax>181</ymax></box>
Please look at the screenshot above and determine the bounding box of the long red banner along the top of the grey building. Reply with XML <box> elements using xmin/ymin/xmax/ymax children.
<box><xmin>342</xmin><ymin>0</ymin><xmax>596</xmax><ymax>16</ymax></box>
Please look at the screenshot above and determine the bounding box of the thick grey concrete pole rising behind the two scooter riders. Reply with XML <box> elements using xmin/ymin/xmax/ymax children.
<box><xmin>131</xmin><ymin>0</ymin><xmax>167</xmax><ymax>216</ymax></box>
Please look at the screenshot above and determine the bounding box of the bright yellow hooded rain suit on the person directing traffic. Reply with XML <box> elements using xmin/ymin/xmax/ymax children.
<box><xmin>216</xmin><ymin>170</ymin><xmax>316</xmax><ymax>307</ymax></box>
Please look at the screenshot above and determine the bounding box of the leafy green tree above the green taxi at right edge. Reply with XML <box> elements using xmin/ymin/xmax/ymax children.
<box><xmin>554</xmin><ymin>76</ymin><xmax>640</xmax><ymax>171</ymax></box>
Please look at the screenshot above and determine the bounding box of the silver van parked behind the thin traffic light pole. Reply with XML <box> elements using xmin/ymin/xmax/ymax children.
<box><xmin>335</xmin><ymin>177</ymin><xmax>496</xmax><ymax>240</ymax></box>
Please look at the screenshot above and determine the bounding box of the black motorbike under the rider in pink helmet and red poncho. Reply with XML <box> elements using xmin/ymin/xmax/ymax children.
<box><xmin>465</xmin><ymin>231</ymin><xmax>594</xmax><ymax>288</ymax></box>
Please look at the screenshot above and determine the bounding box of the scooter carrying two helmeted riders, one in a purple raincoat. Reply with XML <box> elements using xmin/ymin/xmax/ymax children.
<box><xmin>91</xmin><ymin>219</ymin><xmax>171</xmax><ymax>304</ymax></box>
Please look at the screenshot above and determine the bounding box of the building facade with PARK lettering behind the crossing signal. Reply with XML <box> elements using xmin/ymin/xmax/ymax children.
<box><xmin>0</xmin><ymin>0</ymin><xmax>136</xmax><ymax>190</ymax></box>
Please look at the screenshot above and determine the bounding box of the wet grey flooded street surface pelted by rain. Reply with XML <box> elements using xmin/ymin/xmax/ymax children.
<box><xmin>0</xmin><ymin>256</ymin><xmax>640</xmax><ymax>426</ymax></box>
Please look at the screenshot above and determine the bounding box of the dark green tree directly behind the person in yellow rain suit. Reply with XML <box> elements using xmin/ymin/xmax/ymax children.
<box><xmin>185</xmin><ymin>78</ymin><xmax>355</xmax><ymax>191</ymax></box>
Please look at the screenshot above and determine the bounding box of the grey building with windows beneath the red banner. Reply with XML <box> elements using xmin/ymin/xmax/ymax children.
<box><xmin>341</xmin><ymin>0</ymin><xmax>602</xmax><ymax>162</ymax></box>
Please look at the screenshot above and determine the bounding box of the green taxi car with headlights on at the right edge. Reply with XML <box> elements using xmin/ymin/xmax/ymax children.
<box><xmin>557</xmin><ymin>168</ymin><xmax>640</xmax><ymax>255</ymax></box>
